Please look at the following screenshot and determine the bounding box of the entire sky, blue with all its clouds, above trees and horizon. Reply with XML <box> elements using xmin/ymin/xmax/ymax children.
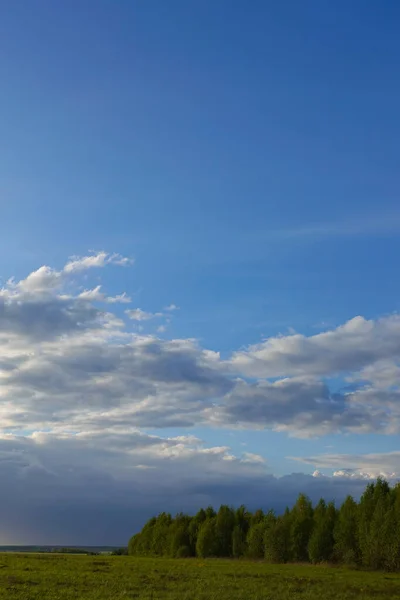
<box><xmin>0</xmin><ymin>0</ymin><xmax>400</xmax><ymax>544</ymax></box>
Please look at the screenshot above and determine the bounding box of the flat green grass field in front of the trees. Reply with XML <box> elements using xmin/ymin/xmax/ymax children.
<box><xmin>0</xmin><ymin>554</ymin><xmax>400</xmax><ymax>600</ymax></box>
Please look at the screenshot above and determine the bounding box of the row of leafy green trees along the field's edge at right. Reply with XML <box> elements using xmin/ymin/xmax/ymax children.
<box><xmin>128</xmin><ymin>479</ymin><xmax>400</xmax><ymax>571</ymax></box>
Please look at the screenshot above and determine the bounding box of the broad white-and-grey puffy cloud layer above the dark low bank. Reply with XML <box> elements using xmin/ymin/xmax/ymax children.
<box><xmin>0</xmin><ymin>252</ymin><xmax>400</xmax><ymax>437</ymax></box>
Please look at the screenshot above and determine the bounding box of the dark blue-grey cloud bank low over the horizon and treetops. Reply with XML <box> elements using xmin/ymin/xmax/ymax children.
<box><xmin>0</xmin><ymin>428</ymin><xmax>378</xmax><ymax>545</ymax></box>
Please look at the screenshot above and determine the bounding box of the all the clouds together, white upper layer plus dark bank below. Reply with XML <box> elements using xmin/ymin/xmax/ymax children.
<box><xmin>0</xmin><ymin>252</ymin><xmax>400</xmax><ymax>543</ymax></box>
